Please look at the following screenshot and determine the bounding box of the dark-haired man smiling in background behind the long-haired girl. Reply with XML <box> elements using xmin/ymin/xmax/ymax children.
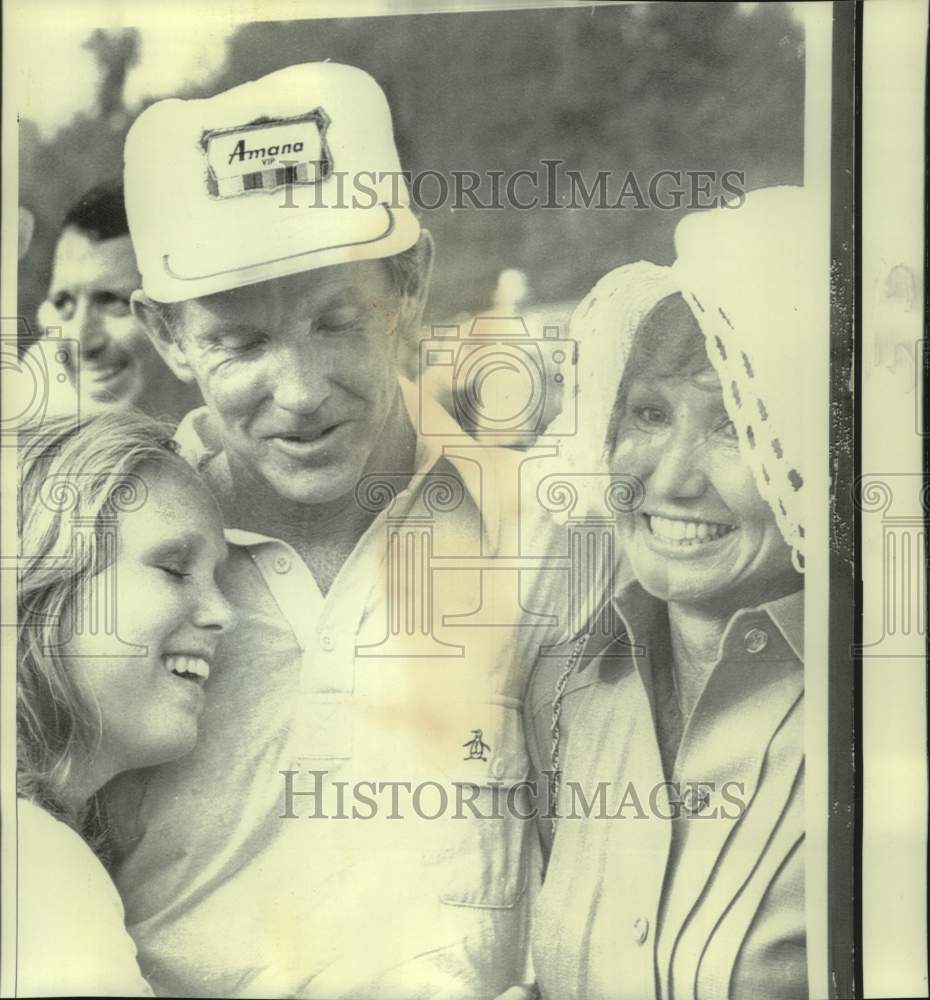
<box><xmin>30</xmin><ymin>181</ymin><xmax>200</xmax><ymax>423</ymax></box>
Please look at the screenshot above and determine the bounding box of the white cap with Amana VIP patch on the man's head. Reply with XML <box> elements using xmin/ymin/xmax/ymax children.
<box><xmin>125</xmin><ymin>62</ymin><xmax>420</xmax><ymax>302</ymax></box>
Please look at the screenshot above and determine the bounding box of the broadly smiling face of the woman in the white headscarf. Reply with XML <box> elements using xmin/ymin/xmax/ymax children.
<box><xmin>611</xmin><ymin>367</ymin><xmax>799</xmax><ymax>615</ymax></box>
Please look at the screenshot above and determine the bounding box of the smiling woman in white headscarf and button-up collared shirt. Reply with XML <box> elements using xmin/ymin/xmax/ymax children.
<box><xmin>528</xmin><ymin>188</ymin><xmax>827</xmax><ymax>1000</ymax></box>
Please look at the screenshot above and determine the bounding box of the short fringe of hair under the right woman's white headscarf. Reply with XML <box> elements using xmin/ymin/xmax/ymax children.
<box><xmin>606</xmin><ymin>292</ymin><xmax>711</xmax><ymax>457</ymax></box>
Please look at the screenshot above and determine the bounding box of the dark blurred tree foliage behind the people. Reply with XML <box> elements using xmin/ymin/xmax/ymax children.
<box><xmin>14</xmin><ymin>3</ymin><xmax>804</xmax><ymax>334</ymax></box>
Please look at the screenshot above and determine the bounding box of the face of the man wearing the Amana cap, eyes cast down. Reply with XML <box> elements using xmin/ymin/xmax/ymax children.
<box><xmin>169</xmin><ymin>261</ymin><xmax>401</xmax><ymax>504</ymax></box>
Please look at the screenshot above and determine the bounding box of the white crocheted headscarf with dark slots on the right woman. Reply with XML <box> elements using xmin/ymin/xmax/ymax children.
<box><xmin>568</xmin><ymin>187</ymin><xmax>829</xmax><ymax>570</ymax></box>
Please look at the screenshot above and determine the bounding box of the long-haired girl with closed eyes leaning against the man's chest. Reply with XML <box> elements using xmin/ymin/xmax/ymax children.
<box><xmin>17</xmin><ymin>413</ymin><xmax>230</xmax><ymax>996</ymax></box>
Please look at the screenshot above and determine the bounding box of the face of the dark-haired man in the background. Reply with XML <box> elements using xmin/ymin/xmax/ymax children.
<box><xmin>39</xmin><ymin>229</ymin><xmax>162</xmax><ymax>407</ymax></box>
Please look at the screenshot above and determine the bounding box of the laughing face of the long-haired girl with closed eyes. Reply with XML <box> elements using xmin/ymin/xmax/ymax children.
<box><xmin>61</xmin><ymin>463</ymin><xmax>231</xmax><ymax>783</ymax></box>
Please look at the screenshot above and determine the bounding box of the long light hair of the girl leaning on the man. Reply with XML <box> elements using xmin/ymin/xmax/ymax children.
<box><xmin>16</xmin><ymin>411</ymin><xmax>194</xmax><ymax>828</ymax></box>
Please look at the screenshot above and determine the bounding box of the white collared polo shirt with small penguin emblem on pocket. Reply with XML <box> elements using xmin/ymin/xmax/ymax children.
<box><xmin>111</xmin><ymin>384</ymin><xmax>588</xmax><ymax>1000</ymax></box>
